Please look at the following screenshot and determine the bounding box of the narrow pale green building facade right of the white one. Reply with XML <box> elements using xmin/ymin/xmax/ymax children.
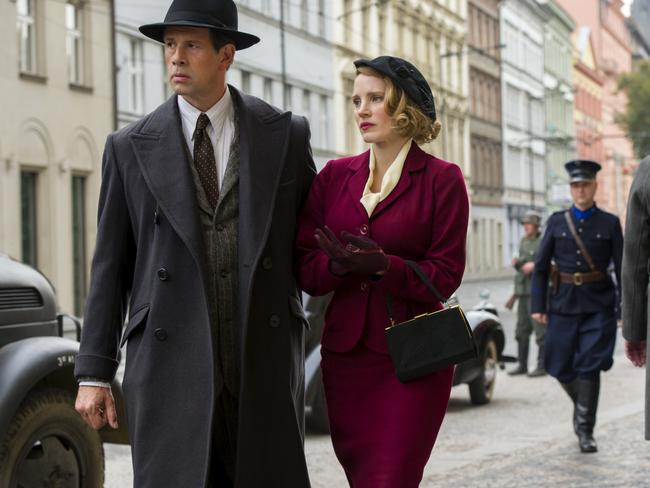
<box><xmin>540</xmin><ymin>0</ymin><xmax>576</xmax><ymax>209</ymax></box>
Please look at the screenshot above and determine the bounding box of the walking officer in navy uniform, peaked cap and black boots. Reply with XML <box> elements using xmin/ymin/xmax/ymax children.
<box><xmin>531</xmin><ymin>160</ymin><xmax>623</xmax><ymax>452</ymax></box>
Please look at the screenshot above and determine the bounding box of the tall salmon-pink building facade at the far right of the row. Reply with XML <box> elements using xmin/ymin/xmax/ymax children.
<box><xmin>557</xmin><ymin>0</ymin><xmax>637</xmax><ymax>222</ymax></box>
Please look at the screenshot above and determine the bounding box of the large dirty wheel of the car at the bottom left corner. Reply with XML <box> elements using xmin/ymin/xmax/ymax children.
<box><xmin>0</xmin><ymin>389</ymin><xmax>104</xmax><ymax>488</ymax></box>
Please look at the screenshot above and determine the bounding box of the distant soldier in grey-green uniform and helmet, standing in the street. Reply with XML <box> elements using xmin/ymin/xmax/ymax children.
<box><xmin>508</xmin><ymin>210</ymin><xmax>546</xmax><ymax>376</ymax></box>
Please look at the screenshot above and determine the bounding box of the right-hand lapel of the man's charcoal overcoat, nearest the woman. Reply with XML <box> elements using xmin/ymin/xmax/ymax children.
<box><xmin>230</xmin><ymin>87</ymin><xmax>291</xmax><ymax>327</ymax></box>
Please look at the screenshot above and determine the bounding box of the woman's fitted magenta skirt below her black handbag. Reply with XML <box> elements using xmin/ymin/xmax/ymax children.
<box><xmin>321</xmin><ymin>344</ymin><xmax>454</xmax><ymax>488</ymax></box>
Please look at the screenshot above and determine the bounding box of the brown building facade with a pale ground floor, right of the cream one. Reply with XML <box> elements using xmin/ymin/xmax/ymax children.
<box><xmin>467</xmin><ymin>0</ymin><xmax>509</xmax><ymax>276</ymax></box>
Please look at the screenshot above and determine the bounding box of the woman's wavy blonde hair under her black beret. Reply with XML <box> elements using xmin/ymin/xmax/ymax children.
<box><xmin>357</xmin><ymin>66</ymin><xmax>442</xmax><ymax>144</ymax></box>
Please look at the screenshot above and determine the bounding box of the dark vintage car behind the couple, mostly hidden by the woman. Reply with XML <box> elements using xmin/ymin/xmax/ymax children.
<box><xmin>305</xmin><ymin>291</ymin><xmax>509</xmax><ymax>432</ymax></box>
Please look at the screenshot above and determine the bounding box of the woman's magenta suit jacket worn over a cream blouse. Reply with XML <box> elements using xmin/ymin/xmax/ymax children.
<box><xmin>297</xmin><ymin>143</ymin><xmax>469</xmax><ymax>353</ymax></box>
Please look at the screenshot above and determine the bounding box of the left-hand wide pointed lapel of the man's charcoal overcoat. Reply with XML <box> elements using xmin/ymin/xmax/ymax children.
<box><xmin>130</xmin><ymin>96</ymin><xmax>205</xmax><ymax>271</ymax></box>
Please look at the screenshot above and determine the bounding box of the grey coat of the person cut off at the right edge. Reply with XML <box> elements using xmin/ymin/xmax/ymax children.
<box><xmin>622</xmin><ymin>156</ymin><xmax>650</xmax><ymax>440</ymax></box>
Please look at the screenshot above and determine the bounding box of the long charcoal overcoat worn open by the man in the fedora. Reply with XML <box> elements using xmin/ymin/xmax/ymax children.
<box><xmin>75</xmin><ymin>87</ymin><xmax>315</xmax><ymax>488</ymax></box>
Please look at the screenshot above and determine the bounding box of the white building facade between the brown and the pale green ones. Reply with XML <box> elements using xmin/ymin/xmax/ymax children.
<box><xmin>500</xmin><ymin>0</ymin><xmax>547</xmax><ymax>262</ymax></box>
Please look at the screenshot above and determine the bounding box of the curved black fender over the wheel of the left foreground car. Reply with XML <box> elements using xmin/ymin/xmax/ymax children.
<box><xmin>0</xmin><ymin>337</ymin><xmax>128</xmax><ymax>444</ymax></box>
